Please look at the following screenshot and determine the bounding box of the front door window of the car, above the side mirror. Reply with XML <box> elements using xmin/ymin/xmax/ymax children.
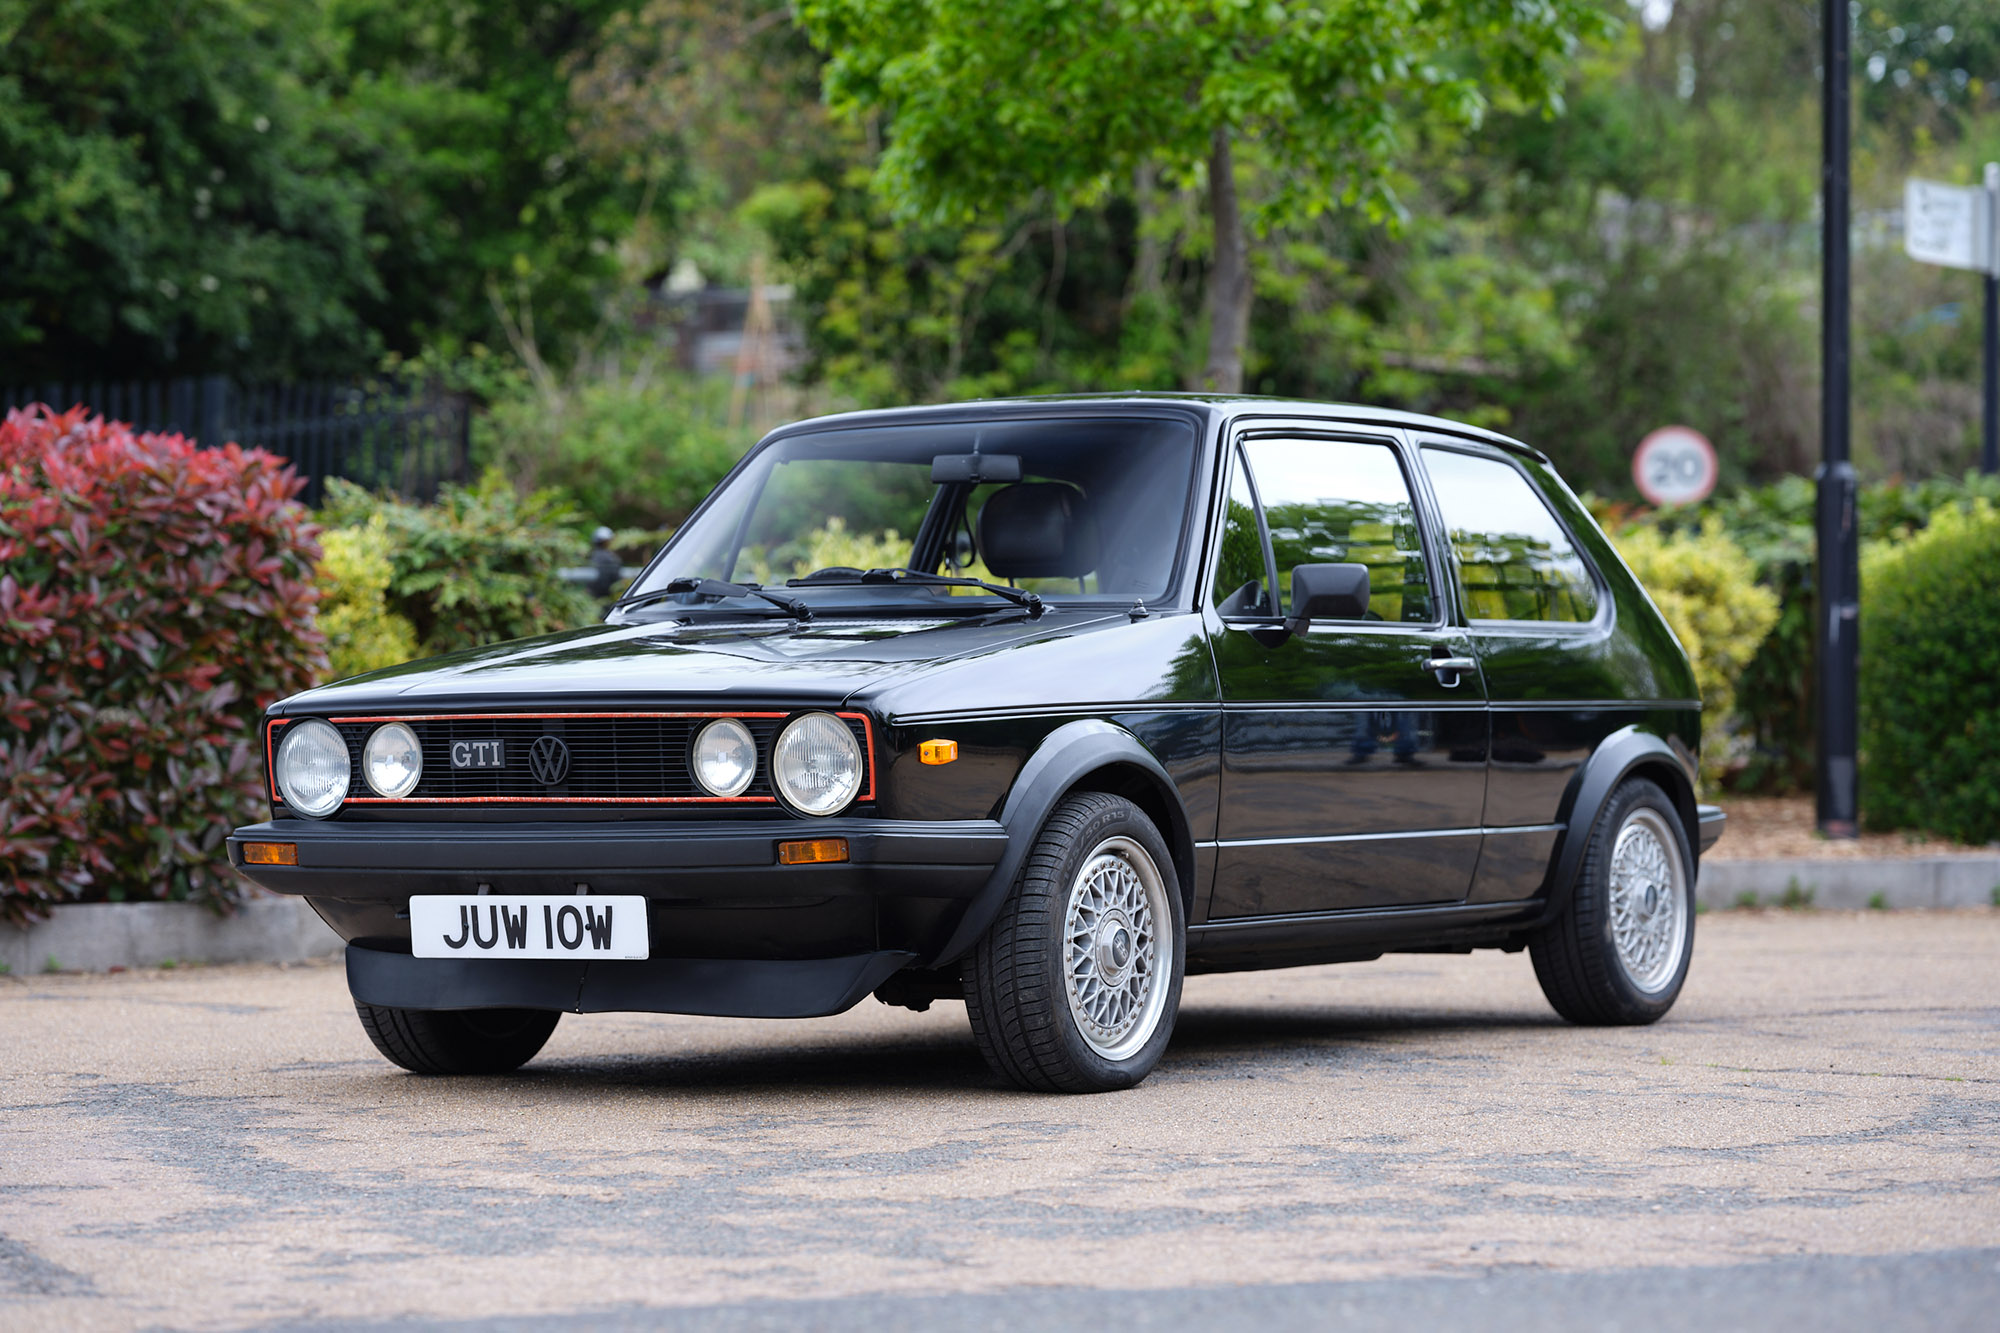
<box><xmin>1218</xmin><ymin>440</ymin><xmax>1434</xmax><ymax>624</ymax></box>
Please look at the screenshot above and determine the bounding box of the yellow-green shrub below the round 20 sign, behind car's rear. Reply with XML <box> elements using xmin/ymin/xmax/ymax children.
<box><xmin>1616</xmin><ymin>522</ymin><xmax>1778</xmax><ymax>783</ymax></box>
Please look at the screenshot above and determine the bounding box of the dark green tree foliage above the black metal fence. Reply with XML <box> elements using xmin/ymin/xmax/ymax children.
<box><xmin>0</xmin><ymin>0</ymin><xmax>656</xmax><ymax>380</ymax></box>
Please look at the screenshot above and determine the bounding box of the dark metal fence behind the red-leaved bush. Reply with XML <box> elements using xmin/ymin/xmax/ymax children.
<box><xmin>0</xmin><ymin>374</ymin><xmax>472</xmax><ymax>504</ymax></box>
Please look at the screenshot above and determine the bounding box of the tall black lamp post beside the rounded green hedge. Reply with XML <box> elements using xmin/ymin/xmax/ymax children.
<box><xmin>1814</xmin><ymin>0</ymin><xmax>1860</xmax><ymax>839</ymax></box>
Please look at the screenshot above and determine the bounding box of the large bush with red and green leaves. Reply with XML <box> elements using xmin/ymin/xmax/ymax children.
<box><xmin>0</xmin><ymin>408</ymin><xmax>326</xmax><ymax>923</ymax></box>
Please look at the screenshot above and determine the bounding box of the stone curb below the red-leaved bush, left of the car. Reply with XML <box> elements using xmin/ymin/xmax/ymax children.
<box><xmin>0</xmin><ymin>899</ymin><xmax>342</xmax><ymax>977</ymax></box>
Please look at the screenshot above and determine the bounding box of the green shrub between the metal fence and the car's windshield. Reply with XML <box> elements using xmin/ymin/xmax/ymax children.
<box><xmin>474</xmin><ymin>372</ymin><xmax>752</xmax><ymax>528</ymax></box>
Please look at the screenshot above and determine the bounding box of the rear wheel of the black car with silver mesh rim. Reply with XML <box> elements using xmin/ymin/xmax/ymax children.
<box><xmin>1528</xmin><ymin>779</ymin><xmax>1694</xmax><ymax>1027</ymax></box>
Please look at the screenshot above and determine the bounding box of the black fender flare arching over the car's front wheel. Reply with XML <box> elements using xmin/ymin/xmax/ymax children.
<box><xmin>938</xmin><ymin>719</ymin><xmax>1194</xmax><ymax>963</ymax></box>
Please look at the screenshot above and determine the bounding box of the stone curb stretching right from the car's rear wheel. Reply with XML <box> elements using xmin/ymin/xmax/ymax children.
<box><xmin>1694</xmin><ymin>857</ymin><xmax>2000</xmax><ymax>909</ymax></box>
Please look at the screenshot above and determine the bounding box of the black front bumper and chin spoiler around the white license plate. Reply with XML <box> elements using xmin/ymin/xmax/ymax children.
<box><xmin>230</xmin><ymin>819</ymin><xmax>1008</xmax><ymax>1019</ymax></box>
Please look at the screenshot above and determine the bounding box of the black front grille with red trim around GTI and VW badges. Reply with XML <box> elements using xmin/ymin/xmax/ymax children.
<box><xmin>270</xmin><ymin>713</ymin><xmax>874</xmax><ymax>805</ymax></box>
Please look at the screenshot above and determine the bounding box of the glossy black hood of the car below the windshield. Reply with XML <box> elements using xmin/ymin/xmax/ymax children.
<box><xmin>278</xmin><ymin>610</ymin><xmax>1124</xmax><ymax>713</ymax></box>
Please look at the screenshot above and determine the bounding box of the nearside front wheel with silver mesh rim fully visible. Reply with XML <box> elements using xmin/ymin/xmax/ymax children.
<box><xmin>964</xmin><ymin>793</ymin><xmax>1188</xmax><ymax>1093</ymax></box>
